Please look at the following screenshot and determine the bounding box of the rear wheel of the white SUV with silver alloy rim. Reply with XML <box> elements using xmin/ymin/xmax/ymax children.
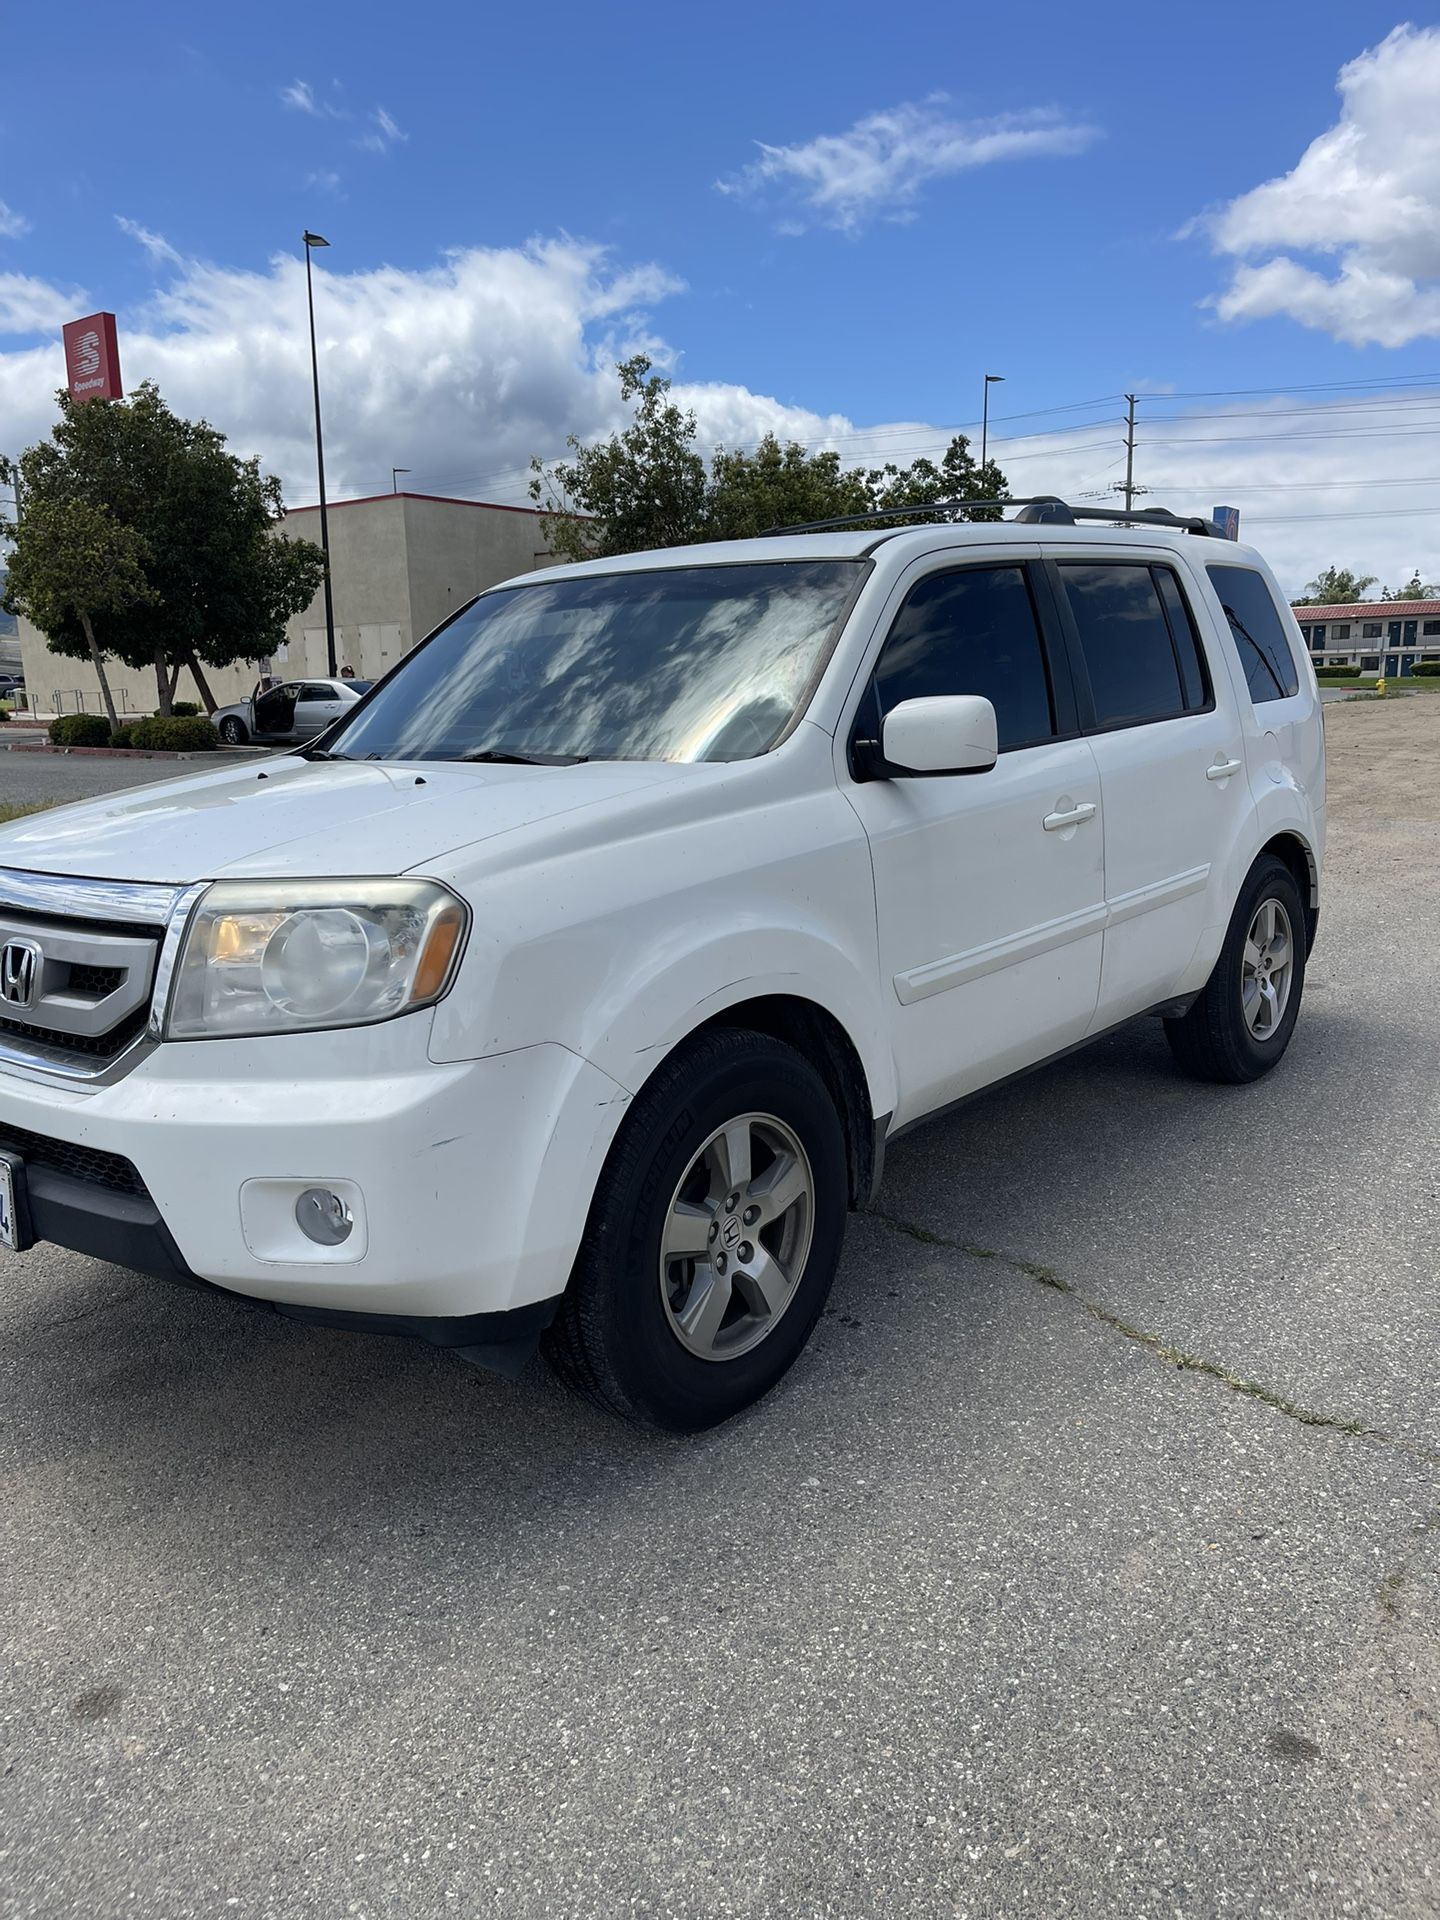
<box><xmin>1165</xmin><ymin>854</ymin><xmax>1306</xmax><ymax>1085</ymax></box>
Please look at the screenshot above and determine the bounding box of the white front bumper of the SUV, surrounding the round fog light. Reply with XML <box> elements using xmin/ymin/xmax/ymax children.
<box><xmin>0</xmin><ymin>1014</ymin><xmax>628</xmax><ymax>1320</ymax></box>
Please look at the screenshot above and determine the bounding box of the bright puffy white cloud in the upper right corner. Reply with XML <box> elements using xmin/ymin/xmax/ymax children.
<box><xmin>1192</xmin><ymin>27</ymin><xmax>1440</xmax><ymax>348</ymax></box>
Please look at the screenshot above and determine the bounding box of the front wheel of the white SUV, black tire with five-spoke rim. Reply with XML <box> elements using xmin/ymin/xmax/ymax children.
<box><xmin>545</xmin><ymin>1029</ymin><xmax>849</xmax><ymax>1432</ymax></box>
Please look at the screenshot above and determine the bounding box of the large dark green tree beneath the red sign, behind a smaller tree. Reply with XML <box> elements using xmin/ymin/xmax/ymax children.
<box><xmin>1</xmin><ymin>382</ymin><xmax>324</xmax><ymax>712</ymax></box>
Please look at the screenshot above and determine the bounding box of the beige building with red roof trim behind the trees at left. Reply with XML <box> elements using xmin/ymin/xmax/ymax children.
<box><xmin>19</xmin><ymin>493</ymin><xmax>549</xmax><ymax>714</ymax></box>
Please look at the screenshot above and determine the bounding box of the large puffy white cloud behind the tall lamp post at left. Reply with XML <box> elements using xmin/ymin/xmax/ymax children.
<box><xmin>0</xmin><ymin>238</ymin><xmax>695</xmax><ymax>503</ymax></box>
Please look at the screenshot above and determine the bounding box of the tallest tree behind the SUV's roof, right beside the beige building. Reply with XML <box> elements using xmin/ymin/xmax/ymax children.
<box><xmin>530</xmin><ymin>353</ymin><xmax>705</xmax><ymax>561</ymax></box>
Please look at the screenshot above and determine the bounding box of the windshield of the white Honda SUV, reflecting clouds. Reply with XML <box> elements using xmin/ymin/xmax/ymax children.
<box><xmin>326</xmin><ymin>561</ymin><xmax>866</xmax><ymax>760</ymax></box>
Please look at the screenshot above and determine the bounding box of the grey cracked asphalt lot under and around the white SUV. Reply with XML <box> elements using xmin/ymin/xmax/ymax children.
<box><xmin>0</xmin><ymin>699</ymin><xmax>1440</xmax><ymax>1920</ymax></box>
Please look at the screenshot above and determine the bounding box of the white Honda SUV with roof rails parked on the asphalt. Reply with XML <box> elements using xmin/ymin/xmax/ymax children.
<box><xmin>0</xmin><ymin>503</ymin><xmax>1325</xmax><ymax>1428</ymax></box>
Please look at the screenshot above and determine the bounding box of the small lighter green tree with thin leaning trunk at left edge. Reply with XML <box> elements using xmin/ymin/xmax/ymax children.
<box><xmin>0</xmin><ymin>495</ymin><xmax>156</xmax><ymax>726</ymax></box>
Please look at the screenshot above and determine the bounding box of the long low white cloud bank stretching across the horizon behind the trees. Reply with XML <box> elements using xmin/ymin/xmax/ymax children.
<box><xmin>0</xmin><ymin>238</ymin><xmax>1440</xmax><ymax>589</ymax></box>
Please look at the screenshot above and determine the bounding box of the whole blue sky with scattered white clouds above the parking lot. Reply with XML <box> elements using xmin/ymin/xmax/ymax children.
<box><xmin>0</xmin><ymin>0</ymin><xmax>1440</xmax><ymax>589</ymax></box>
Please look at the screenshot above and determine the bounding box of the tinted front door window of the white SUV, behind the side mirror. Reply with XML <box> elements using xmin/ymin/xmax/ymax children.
<box><xmin>876</xmin><ymin>566</ymin><xmax>1054</xmax><ymax>749</ymax></box>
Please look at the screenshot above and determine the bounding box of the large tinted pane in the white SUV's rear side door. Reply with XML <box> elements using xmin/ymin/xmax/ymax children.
<box><xmin>1060</xmin><ymin>563</ymin><xmax>1198</xmax><ymax>726</ymax></box>
